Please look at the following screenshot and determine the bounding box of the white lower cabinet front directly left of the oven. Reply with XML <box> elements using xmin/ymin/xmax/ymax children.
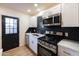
<box><xmin>29</xmin><ymin>35</ymin><xmax>37</xmax><ymax>54</ymax></box>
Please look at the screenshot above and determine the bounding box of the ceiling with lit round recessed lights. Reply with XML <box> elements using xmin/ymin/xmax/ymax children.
<box><xmin>0</xmin><ymin>3</ymin><xmax>58</xmax><ymax>16</ymax></box>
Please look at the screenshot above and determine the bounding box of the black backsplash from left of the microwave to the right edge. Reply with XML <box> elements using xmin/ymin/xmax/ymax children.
<box><xmin>37</xmin><ymin>17</ymin><xmax>79</xmax><ymax>41</ymax></box>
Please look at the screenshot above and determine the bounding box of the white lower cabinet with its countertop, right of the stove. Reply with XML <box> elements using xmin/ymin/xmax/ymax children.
<box><xmin>58</xmin><ymin>40</ymin><xmax>79</xmax><ymax>56</ymax></box>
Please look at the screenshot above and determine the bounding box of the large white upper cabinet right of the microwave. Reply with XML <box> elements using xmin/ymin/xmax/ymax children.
<box><xmin>62</xmin><ymin>3</ymin><xmax>79</xmax><ymax>27</ymax></box>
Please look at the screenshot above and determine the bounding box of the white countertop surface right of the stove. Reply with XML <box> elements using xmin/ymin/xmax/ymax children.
<box><xmin>58</xmin><ymin>39</ymin><xmax>79</xmax><ymax>52</ymax></box>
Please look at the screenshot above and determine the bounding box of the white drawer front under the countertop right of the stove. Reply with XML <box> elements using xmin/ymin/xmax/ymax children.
<box><xmin>58</xmin><ymin>46</ymin><xmax>79</xmax><ymax>56</ymax></box>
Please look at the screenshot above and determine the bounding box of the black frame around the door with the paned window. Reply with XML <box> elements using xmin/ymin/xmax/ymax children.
<box><xmin>1</xmin><ymin>15</ymin><xmax>20</xmax><ymax>51</ymax></box>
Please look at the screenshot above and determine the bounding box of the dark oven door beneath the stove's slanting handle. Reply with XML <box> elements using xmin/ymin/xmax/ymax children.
<box><xmin>38</xmin><ymin>44</ymin><xmax>55</xmax><ymax>56</ymax></box>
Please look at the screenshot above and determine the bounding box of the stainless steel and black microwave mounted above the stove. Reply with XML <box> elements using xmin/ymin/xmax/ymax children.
<box><xmin>43</xmin><ymin>14</ymin><xmax>61</xmax><ymax>26</ymax></box>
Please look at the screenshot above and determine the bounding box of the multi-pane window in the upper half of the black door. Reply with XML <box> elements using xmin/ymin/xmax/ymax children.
<box><xmin>5</xmin><ymin>17</ymin><xmax>17</xmax><ymax>34</ymax></box>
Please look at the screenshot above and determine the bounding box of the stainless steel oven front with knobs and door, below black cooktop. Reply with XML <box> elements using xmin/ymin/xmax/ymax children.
<box><xmin>38</xmin><ymin>37</ymin><xmax>57</xmax><ymax>56</ymax></box>
